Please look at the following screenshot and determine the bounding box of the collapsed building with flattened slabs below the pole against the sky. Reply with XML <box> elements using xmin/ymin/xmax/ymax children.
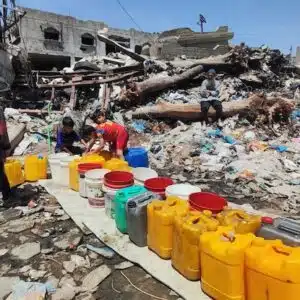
<box><xmin>145</xmin><ymin>26</ymin><xmax>234</xmax><ymax>60</ymax></box>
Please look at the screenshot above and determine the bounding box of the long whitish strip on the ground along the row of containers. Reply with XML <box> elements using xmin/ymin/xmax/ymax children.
<box><xmin>40</xmin><ymin>180</ymin><xmax>210</xmax><ymax>300</ymax></box>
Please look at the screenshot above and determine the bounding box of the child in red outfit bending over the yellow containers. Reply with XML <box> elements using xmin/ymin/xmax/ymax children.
<box><xmin>85</xmin><ymin>112</ymin><xmax>129</xmax><ymax>159</ymax></box>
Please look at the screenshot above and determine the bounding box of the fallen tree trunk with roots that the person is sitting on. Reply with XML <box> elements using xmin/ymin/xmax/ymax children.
<box><xmin>132</xmin><ymin>95</ymin><xmax>294</xmax><ymax>122</ymax></box>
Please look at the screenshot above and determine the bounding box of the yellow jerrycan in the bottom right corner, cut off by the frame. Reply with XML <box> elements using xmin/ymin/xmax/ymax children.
<box><xmin>245</xmin><ymin>240</ymin><xmax>300</xmax><ymax>300</ymax></box>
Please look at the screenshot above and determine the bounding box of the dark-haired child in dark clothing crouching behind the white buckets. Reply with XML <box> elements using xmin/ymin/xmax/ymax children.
<box><xmin>55</xmin><ymin>117</ymin><xmax>87</xmax><ymax>155</ymax></box>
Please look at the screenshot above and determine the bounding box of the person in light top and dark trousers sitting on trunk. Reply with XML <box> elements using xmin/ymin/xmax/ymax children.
<box><xmin>200</xmin><ymin>69</ymin><xmax>223</xmax><ymax>124</ymax></box>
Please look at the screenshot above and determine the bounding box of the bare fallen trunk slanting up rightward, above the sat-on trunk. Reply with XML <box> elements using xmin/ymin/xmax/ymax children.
<box><xmin>120</xmin><ymin>66</ymin><xmax>203</xmax><ymax>102</ymax></box>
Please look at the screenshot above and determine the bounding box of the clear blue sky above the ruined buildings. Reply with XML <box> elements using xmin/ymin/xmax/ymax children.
<box><xmin>16</xmin><ymin>0</ymin><xmax>300</xmax><ymax>53</ymax></box>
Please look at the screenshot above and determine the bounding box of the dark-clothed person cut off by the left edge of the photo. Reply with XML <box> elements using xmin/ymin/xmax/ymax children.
<box><xmin>0</xmin><ymin>107</ymin><xmax>11</xmax><ymax>206</ymax></box>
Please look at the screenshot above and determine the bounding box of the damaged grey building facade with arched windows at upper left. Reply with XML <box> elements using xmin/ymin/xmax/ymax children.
<box><xmin>15</xmin><ymin>8</ymin><xmax>153</xmax><ymax>70</ymax></box>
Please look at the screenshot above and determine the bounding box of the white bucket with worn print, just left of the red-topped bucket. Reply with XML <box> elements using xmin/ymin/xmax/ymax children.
<box><xmin>85</xmin><ymin>169</ymin><xmax>110</xmax><ymax>208</ymax></box>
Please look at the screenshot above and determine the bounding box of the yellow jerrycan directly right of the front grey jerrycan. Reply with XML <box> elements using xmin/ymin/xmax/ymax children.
<box><xmin>147</xmin><ymin>197</ymin><xmax>188</xmax><ymax>259</ymax></box>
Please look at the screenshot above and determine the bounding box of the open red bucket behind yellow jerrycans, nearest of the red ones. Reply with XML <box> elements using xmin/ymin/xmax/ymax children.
<box><xmin>189</xmin><ymin>192</ymin><xmax>227</xmax><ymax>214</ymax></box>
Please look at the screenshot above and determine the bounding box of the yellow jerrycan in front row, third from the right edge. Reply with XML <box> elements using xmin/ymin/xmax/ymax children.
<box><xmin>172</xmin><ymin>211</ymin><xmax>219</xmax><ymax>280</ymax></box>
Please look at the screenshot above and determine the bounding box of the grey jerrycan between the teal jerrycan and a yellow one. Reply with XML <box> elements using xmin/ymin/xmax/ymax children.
<box><xmin>126</xmin><ymin>192</ymin><xmax>156</xmax><ymax>247</ymax></box>
